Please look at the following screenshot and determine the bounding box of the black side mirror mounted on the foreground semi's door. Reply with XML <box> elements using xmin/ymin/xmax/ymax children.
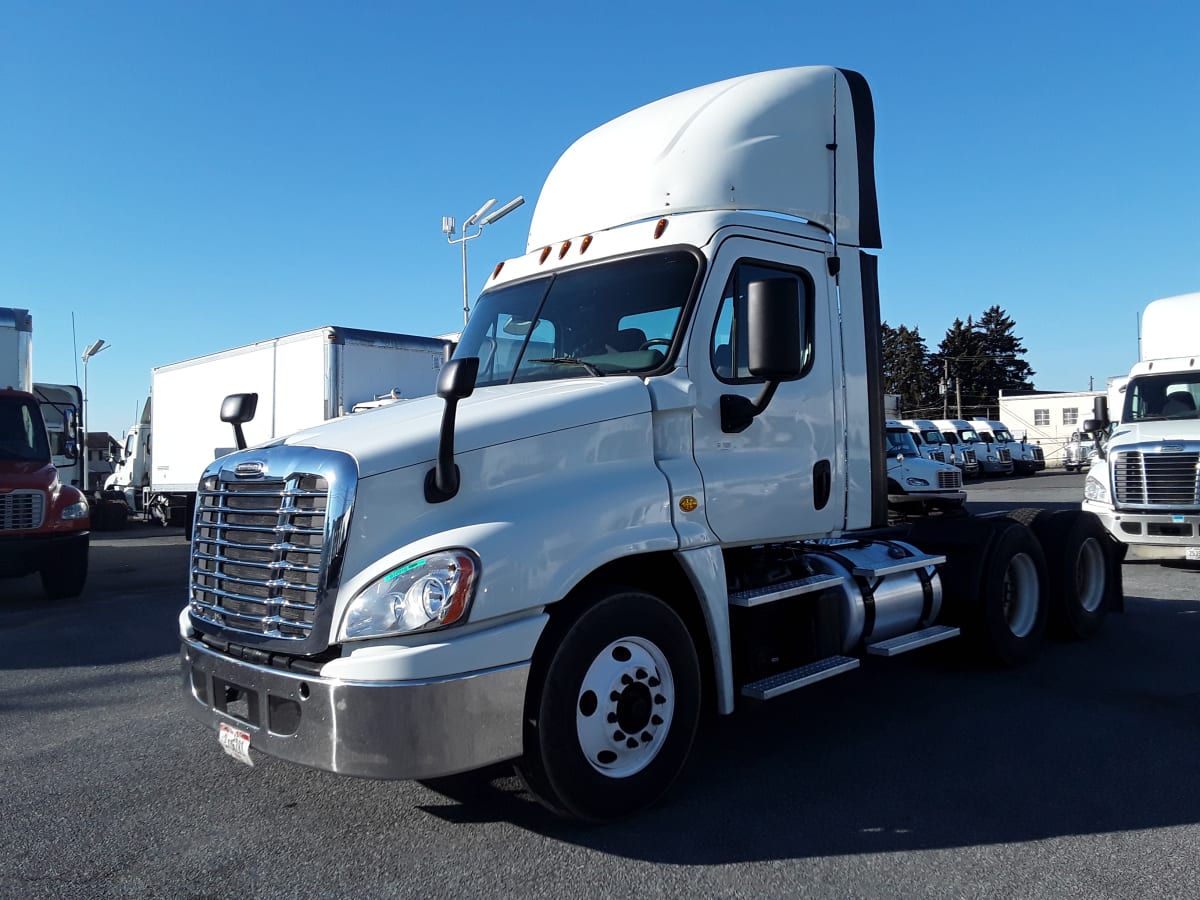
<box><xmin>721</xmin><ymin>278</ymin><xmax>804</xmax><ymax>434</ymax></box>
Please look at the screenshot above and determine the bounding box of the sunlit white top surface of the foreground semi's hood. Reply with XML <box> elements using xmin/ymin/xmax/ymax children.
<box><xmin>276</xmin><ymin>377</ymin><xmax>650</xmax><ymax>478</ymax></box>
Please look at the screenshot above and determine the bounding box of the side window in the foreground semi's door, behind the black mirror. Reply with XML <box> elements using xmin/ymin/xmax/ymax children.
<box><xmin>710</xmin><ymin>260</ymin><xmax>814</xmax><ymax>382</ymax></box>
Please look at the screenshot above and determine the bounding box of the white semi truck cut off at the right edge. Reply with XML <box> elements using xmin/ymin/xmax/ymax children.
<box><xmin>1082</xmin><ymin>293</ymin><xmax>1200</xmax><ymax>562</ymax></box>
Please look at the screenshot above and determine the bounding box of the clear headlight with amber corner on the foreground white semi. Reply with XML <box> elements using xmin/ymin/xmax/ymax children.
<box><xmin>338</xmin><ymin>550</ymin><xmax>479</xmax><ymax>641</ymax></box>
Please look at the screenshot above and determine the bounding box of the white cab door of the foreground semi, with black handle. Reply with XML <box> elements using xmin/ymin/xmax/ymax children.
<box><xmin>688</xmin><ymin>238</ymin><xmax>846</xmax><ymax>544</ymax></box>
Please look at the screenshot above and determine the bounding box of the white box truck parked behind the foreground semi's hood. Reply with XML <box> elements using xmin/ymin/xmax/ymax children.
<box><xmin>145</xmin><ymin>325</ymin><xmax>446</xmax><ymax>524</ymax></box>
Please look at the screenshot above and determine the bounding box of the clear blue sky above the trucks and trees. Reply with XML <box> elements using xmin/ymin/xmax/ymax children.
<box><xmin>0</xmin><ymin>0</ymin><xmax>1200</xmax><ymax>434</ymax></box>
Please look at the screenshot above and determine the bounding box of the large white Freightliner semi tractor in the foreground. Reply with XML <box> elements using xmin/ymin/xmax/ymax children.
<box><xmin>177</xmin><ymin>67</ymin><xmax>1121</xmax><ymax>821</ymax></box>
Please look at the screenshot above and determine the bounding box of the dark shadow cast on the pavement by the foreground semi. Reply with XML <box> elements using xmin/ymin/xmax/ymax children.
<box><xmin>422</xmin><ymin>598</ymin><xmax>1200</xmax><ymax>865</ymax></box>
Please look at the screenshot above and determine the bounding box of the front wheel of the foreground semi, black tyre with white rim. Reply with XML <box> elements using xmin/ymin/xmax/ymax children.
<box><xmin>517</xmin><ymin>589</ymin><xmax>701</xmax><ymax>822</ymax></box>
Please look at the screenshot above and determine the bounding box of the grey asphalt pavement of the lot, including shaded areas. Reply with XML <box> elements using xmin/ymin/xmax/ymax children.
<box><xmin>0</xmin><ymin>473</ymin><xmax>1200</xmax><ymax>899</ymax></box>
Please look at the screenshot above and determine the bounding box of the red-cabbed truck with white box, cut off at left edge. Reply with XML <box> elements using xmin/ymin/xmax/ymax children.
<box><xmin>0</xmin><ymin>307</ymin><xmax>89</xmax><ymax>599</ymax></box>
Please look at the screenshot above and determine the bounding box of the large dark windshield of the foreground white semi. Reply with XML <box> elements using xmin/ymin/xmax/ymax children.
<box><xmin>455</xmin><ymin>250</ymin><xmax>700</xmax><ymax>386</ymax></box>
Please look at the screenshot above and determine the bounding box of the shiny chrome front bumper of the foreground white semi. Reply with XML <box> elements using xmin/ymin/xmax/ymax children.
<box><xmin>180</xmin><ymin>637</ymin><xmax>529</xmax><ymax>779</ymax></box>
